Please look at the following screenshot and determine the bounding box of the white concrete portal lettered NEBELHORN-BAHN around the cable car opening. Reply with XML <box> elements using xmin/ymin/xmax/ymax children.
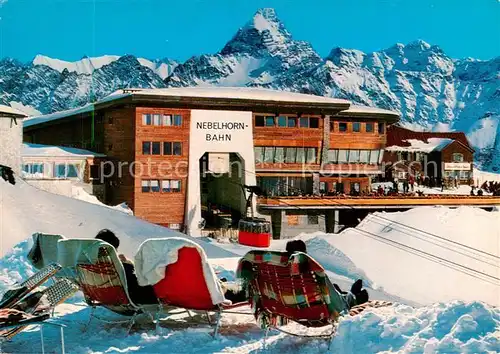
<box><xmin>185</xmin><ymin>110</ymin><xmax>256</xmax><ymax>236</ymax></box>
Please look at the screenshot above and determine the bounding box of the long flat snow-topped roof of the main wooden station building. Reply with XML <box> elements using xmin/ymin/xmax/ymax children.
<box><xmin>24</xmin><ymin>87</ymin><xmax>399</xmax><ymax>128</ymax></box>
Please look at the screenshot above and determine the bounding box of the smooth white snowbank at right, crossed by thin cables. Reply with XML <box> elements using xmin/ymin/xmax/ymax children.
<box><xmin>320</xmin><ymin>207</ymin><xmax>500</xmax><ymax>306</ymax></box>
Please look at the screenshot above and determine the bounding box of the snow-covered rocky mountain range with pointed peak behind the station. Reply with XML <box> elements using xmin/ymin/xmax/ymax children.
<box><xmin>0</xmin><ymin>9</ymin><xmax>500</xmax><ymax>171</ymax></box>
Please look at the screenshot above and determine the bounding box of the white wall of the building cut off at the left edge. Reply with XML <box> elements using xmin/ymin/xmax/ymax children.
<box><xmin>0</xmin><ymin>116</ymin><xmax>23</xmax><ymax>176</ymax></box>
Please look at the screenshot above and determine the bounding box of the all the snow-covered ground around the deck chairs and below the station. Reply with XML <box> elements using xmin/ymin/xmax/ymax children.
<box><xmin>0</xmin><ymin>180</ymin><xmax>500</xmax><ymax>354</ymax></box>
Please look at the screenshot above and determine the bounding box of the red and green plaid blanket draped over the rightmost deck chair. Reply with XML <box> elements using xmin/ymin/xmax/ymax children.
<box><xmin>236</xmin><ymin>251</ymin><xmax>348</xmax><ymax>324</ymax></box>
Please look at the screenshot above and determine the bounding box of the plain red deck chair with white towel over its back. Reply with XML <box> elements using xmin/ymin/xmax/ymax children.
<box><xmin>135</xmin><ymin>237</ymin><xmax>248</xmax><ymax>336</ymax></box>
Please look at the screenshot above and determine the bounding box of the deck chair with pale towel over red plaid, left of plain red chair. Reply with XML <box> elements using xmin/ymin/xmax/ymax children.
<box><xmin>57</xmin><ymin>239</ymin><xmax>157</xmax><ymax>331</ymax></box>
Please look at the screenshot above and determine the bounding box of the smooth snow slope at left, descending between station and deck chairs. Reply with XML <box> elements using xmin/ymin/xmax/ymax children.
<box><xmin>0</xmin><ymin>178</ymin><xmax>234</xmax><ymax>258</ymax></box>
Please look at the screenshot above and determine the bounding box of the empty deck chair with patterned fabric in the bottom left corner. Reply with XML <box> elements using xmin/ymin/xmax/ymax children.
<box><xmin>0</xmin><ymin>279</ymin><xmax>78</xmax><ymax>353</ymax></box>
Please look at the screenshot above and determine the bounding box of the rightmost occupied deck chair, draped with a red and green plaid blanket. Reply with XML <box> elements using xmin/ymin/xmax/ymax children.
<box><xmin>237</xmin><ymin>251</ymin><xmax>380</xmax><ymax>343</ymax></box>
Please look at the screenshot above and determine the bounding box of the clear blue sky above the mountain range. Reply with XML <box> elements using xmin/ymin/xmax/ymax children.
<box><xmin>0</xmin><ymin>0</ymin><xmax>500</xmax><ymax>61</ymax></box>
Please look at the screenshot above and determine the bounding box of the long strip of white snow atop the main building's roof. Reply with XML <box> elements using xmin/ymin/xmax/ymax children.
<box><xmin>125</xmin><ymin>87</ymin><xmax>350</xmax><ymax>104</ymax></box>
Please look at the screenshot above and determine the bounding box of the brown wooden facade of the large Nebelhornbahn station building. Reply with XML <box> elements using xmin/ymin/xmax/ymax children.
<box><xmin>24</xmin><ymin>91</ymin><xmax>398</xmax><ymax>228</ymax></box>
